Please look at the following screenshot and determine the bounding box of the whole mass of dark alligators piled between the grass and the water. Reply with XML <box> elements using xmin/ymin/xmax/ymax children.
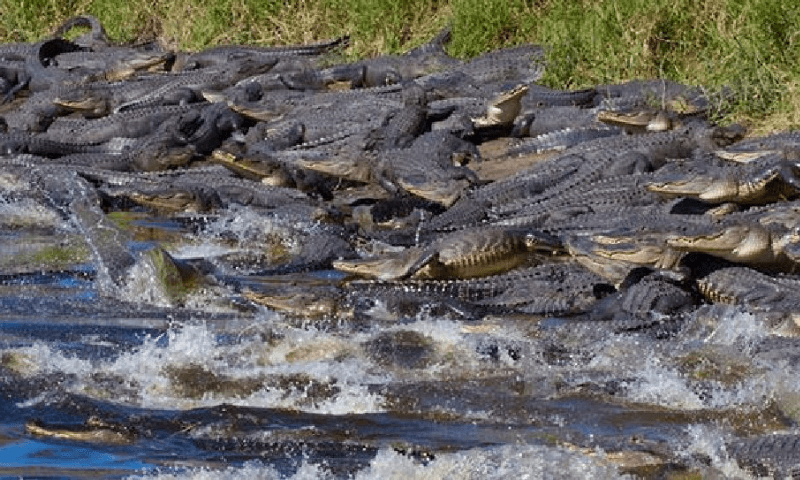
<box><xmin>0</xmin><ymin>16</ymin><xmax>800</xmax><ymax>476</ymax></box>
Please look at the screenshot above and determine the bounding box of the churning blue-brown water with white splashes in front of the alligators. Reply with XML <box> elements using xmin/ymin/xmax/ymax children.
<box><xmin>0</xmin><ymin>211</ymin><xmax>800</xmax><ymax>478</ymax></box>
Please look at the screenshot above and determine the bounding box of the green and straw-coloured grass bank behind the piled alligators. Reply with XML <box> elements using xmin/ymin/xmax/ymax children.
<box><xmin>0</xmin><ymin>0</ymin><xmax>800</xmax><ymax>132</ymax></box>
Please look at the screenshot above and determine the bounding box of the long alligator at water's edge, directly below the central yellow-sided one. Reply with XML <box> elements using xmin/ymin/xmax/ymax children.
<box><xmin>243</xmin><ymin>262</ymin><xmax>614</xmax><ymax>320</ymax></box>
